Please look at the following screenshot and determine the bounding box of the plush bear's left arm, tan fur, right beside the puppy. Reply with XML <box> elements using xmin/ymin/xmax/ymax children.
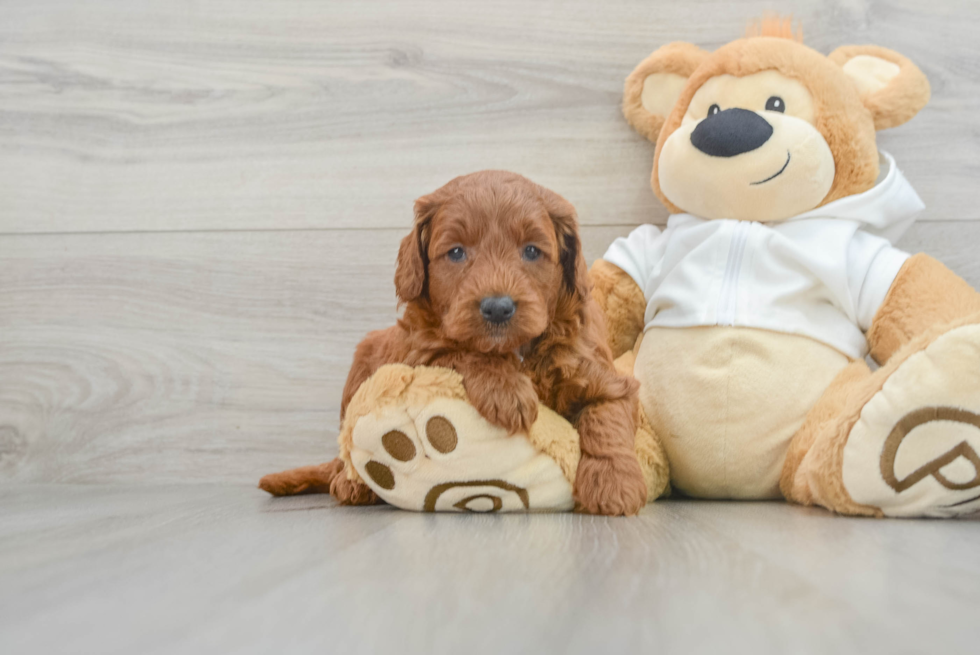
<box><xmin>589</xmin><ymin>259</ymin><xmax>646</xmax><ymax>358</ymax></box>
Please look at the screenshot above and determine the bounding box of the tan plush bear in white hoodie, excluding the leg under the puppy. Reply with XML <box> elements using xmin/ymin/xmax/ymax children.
<box><xmin>591</xmin><ymin>20</ymin><xmax>980</xmax><ymax>517</ymax></box>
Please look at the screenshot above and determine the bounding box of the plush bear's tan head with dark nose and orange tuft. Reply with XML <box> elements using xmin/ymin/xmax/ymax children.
<box><xmin>623</xmin><ymin>19</ymin><xmax>929</xmax><ymax>221</ymax></box>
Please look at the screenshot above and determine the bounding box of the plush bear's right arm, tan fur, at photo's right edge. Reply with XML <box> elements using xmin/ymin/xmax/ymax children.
<box><xmin>867</xmin><ymin>253</ymin><xmax>980</xmax><ymax>364</ymax></box>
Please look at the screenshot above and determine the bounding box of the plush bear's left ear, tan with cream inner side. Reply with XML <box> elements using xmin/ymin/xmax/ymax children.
<box><xmin>623</xmin><ymin>41</ymin><xmax>708</xmax><ymax>143</ymax></box>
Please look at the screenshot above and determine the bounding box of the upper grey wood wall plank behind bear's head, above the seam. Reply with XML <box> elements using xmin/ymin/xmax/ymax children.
<box><xmin>0</xmin><ymin>0</ymin><xmax>980</xmax><ymax>233</ymax></box>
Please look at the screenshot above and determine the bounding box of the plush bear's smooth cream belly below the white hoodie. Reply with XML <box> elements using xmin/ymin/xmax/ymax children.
<box><xmin>635</xmin><ymin>327</ymin><xmax>848</xmax><ymax>498</ymax></box>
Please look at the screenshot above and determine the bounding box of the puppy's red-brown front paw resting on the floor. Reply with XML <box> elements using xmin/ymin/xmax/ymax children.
<box><xmin>574</xmin><ymin>453</ymin><xmax>647</xmax><ymax>516</ymax></box>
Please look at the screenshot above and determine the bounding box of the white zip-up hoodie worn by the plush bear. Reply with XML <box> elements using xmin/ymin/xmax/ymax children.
<box><xmin>603</xmin><ymin>152</ymin><xmax>925</xmax><ymax>359</ymax></box>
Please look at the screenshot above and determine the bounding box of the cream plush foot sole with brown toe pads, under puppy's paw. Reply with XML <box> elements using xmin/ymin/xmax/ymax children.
<box><xmin>350</xmin><ymin>398</ymin><xmax>573</xmax><ymax>512</ymax></box>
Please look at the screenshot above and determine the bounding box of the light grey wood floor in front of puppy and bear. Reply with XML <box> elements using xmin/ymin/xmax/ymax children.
<box><xmin>0</xmin><ymin>485</ymin><xmax>980</xmax><ymax>655</ymax></box>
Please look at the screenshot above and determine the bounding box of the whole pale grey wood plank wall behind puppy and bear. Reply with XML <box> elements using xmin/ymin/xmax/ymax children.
<box><xmin>0</xmin><ymin>0</ymin><xmax>980</xmax><ymax>483</ymax></box>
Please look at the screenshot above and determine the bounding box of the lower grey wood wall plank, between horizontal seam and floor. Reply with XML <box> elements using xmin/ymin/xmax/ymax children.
<box><xmin>0</xmin><ymin>221</ymin><xmax>980</xmax><ymax>483</ymax></box>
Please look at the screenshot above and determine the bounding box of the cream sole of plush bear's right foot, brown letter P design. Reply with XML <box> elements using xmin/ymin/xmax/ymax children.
<box><xmin>842</xmin><ymin>324</ymin><xmax>980</xmax><ymax>517</ymax></box>
